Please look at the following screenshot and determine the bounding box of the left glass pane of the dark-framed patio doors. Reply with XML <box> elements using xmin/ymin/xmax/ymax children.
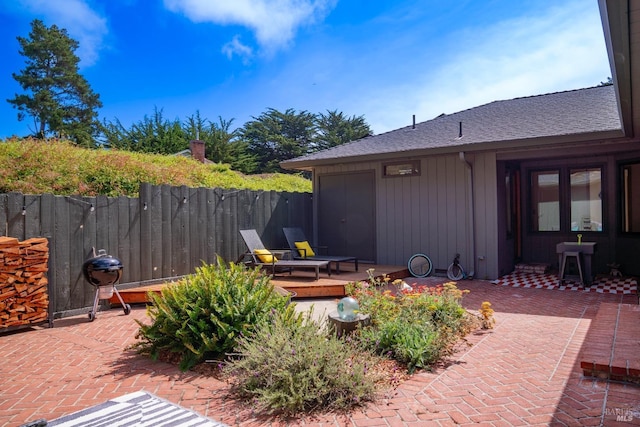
<box><xmin>531</xmin><ymin>171</ymin><xmax>560</xmax><ymax>231</ymax></box>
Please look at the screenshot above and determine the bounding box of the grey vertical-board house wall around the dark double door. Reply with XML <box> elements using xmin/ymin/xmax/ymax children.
<box><xmin>314</xmin><ymin>153</ymin><xmax>498</xmax><ymax>279</ymax></box>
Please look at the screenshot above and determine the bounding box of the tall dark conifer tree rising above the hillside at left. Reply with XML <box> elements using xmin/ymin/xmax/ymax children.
<box><xmin>7</xmin><ymin>19</ymin><xmax>102</xmax><ymax>146</ymax></box>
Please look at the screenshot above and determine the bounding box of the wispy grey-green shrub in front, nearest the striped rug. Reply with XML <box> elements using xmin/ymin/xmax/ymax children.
<box><xmin>224</xmin><ymin>313</ymin><xmax>382</xmax><ymax>415</ymax></box>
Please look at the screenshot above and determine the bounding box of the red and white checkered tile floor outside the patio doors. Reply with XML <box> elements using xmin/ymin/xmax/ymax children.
<box><xmin>491</xmin><ymin>273</ymin><xmax>638</xmax><ymax>294</ymax></box>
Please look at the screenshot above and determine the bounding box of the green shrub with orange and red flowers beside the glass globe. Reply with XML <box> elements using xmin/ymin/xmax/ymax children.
<box><xmin>347</xmin><ymin>281</ymin><xmax>475</xmax><ymax>372</ymax></box>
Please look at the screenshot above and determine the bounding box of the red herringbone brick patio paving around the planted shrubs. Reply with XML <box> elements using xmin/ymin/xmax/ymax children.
<box><xmin>0</xmin><ymin>279</ymin><xmax>640</xmax><ymax>427</ymax></box>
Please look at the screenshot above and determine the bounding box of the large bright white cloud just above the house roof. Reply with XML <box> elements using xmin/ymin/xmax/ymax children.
<box><xmin>353</xmin><ymin>1</ymin><xmax>611</xmax><ymax>133</ymax></box>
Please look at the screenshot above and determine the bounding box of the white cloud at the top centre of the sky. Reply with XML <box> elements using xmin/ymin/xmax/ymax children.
<box><xmin>164</xmin><ymin>0</ymin><xmax>337</xmax><ymax>52</ymax></box>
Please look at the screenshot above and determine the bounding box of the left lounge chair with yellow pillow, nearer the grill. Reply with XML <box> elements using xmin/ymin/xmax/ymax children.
<box><xmin>240</xmin><ymin>229</ymin><xmax>331</xmax><ymax>280</ymax></box>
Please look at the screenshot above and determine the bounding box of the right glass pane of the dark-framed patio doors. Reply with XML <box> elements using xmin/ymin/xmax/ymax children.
<box><xmin>569</xmin><ymin>168</ymin><xmax>602</xmax><ymax>231</ymax></box>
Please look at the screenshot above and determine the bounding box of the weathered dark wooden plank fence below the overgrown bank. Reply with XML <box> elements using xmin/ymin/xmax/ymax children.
<box><xmin>0</xmin><ymin>184</ymin><xmax>312</xmax><ymax>318</ymax></box>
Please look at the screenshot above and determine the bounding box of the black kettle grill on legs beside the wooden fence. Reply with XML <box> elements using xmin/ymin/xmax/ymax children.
<box><xmin>82</xmin><ymin>249</ymin><xmax>131</xmax><ymax>322</ymax></box>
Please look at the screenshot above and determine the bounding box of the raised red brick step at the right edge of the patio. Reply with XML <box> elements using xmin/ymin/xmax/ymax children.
<box><xmin>580</xmin><ymin>303</ymin><xmax>640</xmax><ymax>384</ymax></box>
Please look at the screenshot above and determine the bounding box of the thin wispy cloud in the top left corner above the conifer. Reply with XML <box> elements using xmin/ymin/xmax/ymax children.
<box><xmin>11</xmin><ymin>0</ymin><xmax>108</xmax><ymax>67</ymax></box>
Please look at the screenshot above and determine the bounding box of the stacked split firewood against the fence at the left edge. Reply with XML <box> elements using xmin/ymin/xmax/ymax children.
<box><xmin>0</xmin><ymin>237</ymin><xmax>49</xmax><ymax>332</ymax></box>
